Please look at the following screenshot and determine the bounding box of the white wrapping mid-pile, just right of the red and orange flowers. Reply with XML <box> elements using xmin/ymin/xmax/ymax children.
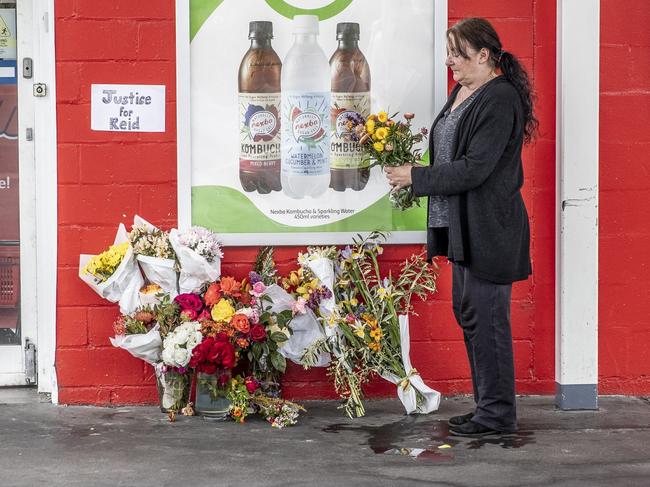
<box><xmin>264</xmin><ymin>284</ymin><xmax>330</xmax><ymax>367</ymax></box>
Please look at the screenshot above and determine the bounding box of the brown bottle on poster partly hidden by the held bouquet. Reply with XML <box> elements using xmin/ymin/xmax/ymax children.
<box><xmin>330</xmin><ymin>22</ymin><xmax>370</xmax><ymax>191</ymax></box>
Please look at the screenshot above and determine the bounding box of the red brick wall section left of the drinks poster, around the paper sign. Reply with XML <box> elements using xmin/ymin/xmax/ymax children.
<box><xmin>55</xmin><ymin>0</ymin><xmax>176</xmax><ymax>404</ymax></box>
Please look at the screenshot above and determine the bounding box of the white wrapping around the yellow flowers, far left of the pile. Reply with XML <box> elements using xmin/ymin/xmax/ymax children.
<box><xmin>79</xmin><ymin>223</ymin><xmax>144</xmax><ymax>314</ymax></box>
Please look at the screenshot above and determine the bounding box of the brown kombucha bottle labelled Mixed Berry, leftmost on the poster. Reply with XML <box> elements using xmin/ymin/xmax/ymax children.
<box><xmin>239</xmin><ymin>21</ymin><xmax>282</xmax><ymax>194</ymax></box>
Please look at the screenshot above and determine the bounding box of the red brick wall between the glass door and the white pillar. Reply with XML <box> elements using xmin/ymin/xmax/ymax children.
<box><xmin>56</xmin><ymin>0</ymin><xmax>555</xmax><ymax>404</ymax></box>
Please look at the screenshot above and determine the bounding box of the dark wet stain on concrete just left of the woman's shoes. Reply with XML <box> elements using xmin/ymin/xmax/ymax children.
<box><xmin>323</xmin><ymin>416</ymin><xmax>458</xmax><ymax>461</ymax></box>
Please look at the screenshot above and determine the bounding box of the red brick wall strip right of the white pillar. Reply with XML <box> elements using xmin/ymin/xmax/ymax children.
<box><xmin>598</xmin><ymin>0</ymin><xmax>650</xmax><ymax>394</ymax></box>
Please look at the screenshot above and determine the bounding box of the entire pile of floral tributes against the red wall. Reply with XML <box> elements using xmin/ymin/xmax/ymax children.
<box><xmin>79</xmin><ymin>216</ymin><xmax>440</xmax><ymax>428</ymax></box>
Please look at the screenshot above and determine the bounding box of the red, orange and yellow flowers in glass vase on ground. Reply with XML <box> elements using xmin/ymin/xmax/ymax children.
<box><xmin>185</xmin><ymin>266</ymin><xmax>299</xmax><ymax>425</ymax></box>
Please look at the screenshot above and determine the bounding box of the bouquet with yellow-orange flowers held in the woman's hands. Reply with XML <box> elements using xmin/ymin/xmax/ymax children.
<box><xmin>347</xmin><ymin>112</ymin><xmax>427</xmax><ymax>210</ymax></box>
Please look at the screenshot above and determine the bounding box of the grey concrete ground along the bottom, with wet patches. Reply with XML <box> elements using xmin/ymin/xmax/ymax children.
<box><xmin>0</xmin><ymin>389</ymin><xmax>650</xmax><ymax>487</ymax></box>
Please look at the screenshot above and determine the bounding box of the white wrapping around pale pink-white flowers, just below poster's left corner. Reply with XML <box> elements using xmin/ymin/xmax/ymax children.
<box><xmin>169</xmin><ymin>228</ymin><xmax>221</xmax><ymax>294</ymax></box>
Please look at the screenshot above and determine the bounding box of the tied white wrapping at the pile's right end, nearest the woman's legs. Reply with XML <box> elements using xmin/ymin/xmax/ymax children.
<box><xmin>382</xmin><ymin>315</ymin><xmax>440</xmax><ymax>414</ymax></box>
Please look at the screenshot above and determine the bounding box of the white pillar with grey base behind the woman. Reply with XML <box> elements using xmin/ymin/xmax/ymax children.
<box><xmin>555</xmin><ymin>0</ymin><xmax>600</xmax><ymax>410</ymax></box>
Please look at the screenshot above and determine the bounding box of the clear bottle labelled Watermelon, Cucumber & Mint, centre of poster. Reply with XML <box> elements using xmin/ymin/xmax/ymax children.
<box><xmin>281</xmin><ymin>15</ymin><xmax>331</xmax><ymax>198</ymax></box>
